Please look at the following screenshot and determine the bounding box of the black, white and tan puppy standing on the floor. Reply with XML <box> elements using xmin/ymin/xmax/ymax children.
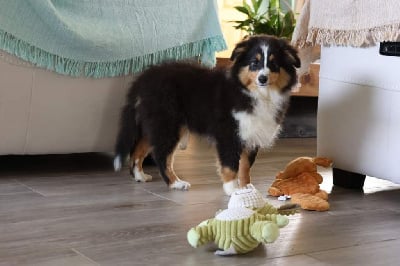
<box><xmin>114</xmin><ymin>35</ymin><xmax>300</xmax><ymax>195</ymax></box>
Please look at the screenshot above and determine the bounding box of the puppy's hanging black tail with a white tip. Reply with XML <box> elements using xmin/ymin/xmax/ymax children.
<box><xmin>114</xmin><ymin>104</ymin><xmax>140</xmax><ymax>171</ymax></box>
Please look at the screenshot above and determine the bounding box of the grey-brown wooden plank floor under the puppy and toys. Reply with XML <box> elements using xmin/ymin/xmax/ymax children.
<box><xmin>0</xmin><ymin>139</ymin><xmax>400</xmax><ymax>266</ymax></box>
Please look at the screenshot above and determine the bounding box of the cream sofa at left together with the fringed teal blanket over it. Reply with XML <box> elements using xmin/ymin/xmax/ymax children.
<box><xmin>0</xmin><ymin>0</ymin><xmax>226</xmax><ymax>155</ymax></box>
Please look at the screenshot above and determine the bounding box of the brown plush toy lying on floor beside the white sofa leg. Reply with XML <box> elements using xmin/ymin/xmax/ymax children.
<box><xmin>268</xmin><ymin>157</ymin><xmax>332</xmax><ymax>211</ymax></box>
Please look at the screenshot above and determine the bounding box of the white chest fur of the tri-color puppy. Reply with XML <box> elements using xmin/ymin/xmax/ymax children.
<box><xmin>232</xmin><ymin>87</ymin><xmax>288</xmax><ymax>149</ymax></box>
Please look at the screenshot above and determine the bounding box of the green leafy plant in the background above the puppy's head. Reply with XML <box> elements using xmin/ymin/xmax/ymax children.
<box><xmin>232</xmin><ymin>0</ymin><xmax>296</xmax><ymax>39</ymax></box>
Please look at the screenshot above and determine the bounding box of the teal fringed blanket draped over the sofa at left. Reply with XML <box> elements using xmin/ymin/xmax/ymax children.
<box><xmin>0</xmin><ymin>0</ymin><xmax>226</xmax><ymax>78</ymax></box>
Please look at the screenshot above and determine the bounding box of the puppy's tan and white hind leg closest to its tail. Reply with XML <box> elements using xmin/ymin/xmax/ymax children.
<box><xmin>130</xmin><ymin>138</ymin><xmax>152</xmax><ymax>182</ymax></box>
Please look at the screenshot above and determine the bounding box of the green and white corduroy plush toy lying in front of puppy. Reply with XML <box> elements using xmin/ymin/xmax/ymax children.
<box><xmin>187</xmin><ymin>185</ymin><xmax>298</xmax><ymax>255</ymax></box>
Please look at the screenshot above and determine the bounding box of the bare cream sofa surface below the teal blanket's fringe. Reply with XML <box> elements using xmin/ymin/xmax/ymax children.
<box><xmin>0</xmin><ymin>50</ymin><xmax>133</xmax><ymax>155</ymax></box>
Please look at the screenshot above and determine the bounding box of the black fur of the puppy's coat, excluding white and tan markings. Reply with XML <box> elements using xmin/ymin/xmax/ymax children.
<box><xmin>115</xmin><ymin>36</ymin><xmax>300</xmax><ymax>189</ymax></box>
